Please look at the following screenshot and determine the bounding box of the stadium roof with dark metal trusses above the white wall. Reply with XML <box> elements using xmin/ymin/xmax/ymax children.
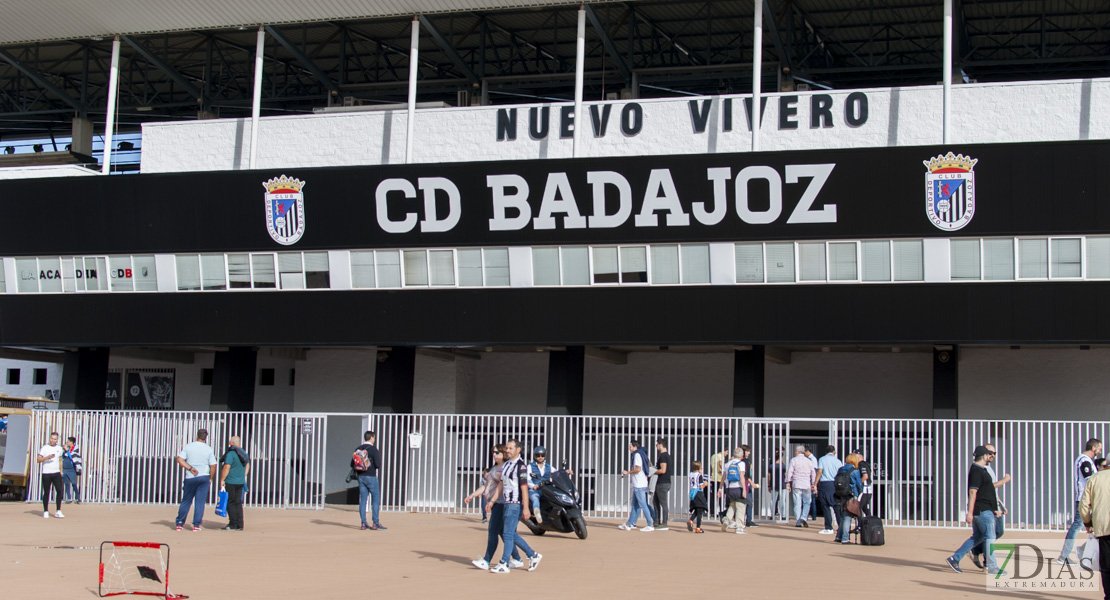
<box><xmin>0</xmin><ymin>0</ymin><xmax>1110</xmax><ymax>146</ymax></box>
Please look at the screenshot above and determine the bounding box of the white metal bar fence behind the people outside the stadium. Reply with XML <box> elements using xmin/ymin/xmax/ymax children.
<box><xmin>30</xmin><ymin>410</ymin><xmax>1110</xmax><ymax>531</ymax></box>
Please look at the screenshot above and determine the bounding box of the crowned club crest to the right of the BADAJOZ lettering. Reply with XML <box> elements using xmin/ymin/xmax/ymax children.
<box><xmin>921</xmin><ymin>152</ymin><xmax>979</xmax><ymax>232</ymax></box>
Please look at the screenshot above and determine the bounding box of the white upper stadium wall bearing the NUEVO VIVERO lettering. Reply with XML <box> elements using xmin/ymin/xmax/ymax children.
<box><xmin>141</xmin><ymin>79</ymin><xmax>1110</xmax><ymax>173</ymax></box>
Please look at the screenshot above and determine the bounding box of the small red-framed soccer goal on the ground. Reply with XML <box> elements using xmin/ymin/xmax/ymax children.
<box><xmin>98</xmin><ymin>541</ymin><xmax>189</xmax><ymax>599</ymax></box>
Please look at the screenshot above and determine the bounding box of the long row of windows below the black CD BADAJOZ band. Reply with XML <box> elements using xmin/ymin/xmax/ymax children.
<box><xmin>0</xmin><ymin>236</ymin><xmax>1110</xmax><ymax>294</ymax></box>
